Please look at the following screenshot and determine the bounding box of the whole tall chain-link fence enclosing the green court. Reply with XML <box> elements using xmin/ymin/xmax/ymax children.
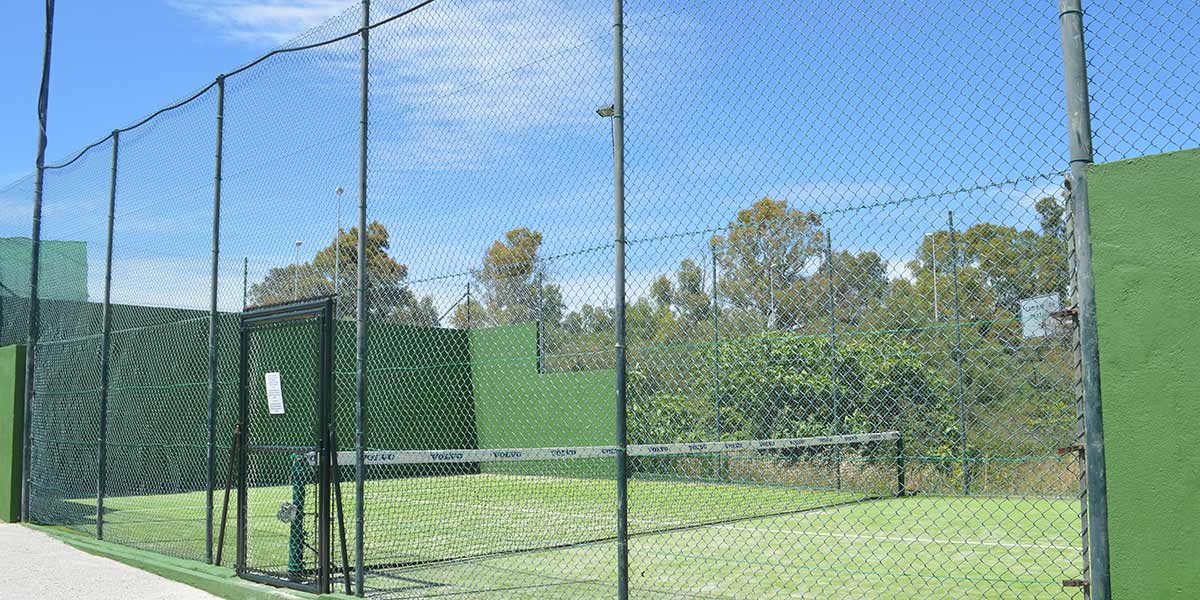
<box><xmin>0</xmin><ymin>0</ymin><xmax>1200</xmax><ymax>599</ymax></box>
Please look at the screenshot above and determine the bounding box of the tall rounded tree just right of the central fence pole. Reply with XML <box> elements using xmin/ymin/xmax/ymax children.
<box><xmin>712</xmin><ymin>197</ymin><xmax>824</xmax><ymax>330</ymax></box>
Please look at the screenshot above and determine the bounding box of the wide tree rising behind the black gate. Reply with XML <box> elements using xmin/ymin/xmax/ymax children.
<box><xmin>250</xmin><ymin>221</ymin><xmax>438</xmax><ymax>326</ymax></box>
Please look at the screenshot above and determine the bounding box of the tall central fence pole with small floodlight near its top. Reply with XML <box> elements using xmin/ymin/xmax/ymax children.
<box><xmin>611</xmin><ymin>0</ymin><xmax>629</xmax><ymax>600</ymax></box>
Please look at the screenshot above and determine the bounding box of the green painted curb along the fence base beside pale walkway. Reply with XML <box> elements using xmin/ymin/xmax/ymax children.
<box><xmin>25</xmin><ymin>523</ymin><xmax>356</xmax><ymax>600</ymax></box>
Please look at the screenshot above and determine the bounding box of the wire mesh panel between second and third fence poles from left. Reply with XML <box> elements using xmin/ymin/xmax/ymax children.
<box><xmin>102</xmin><ymin>88</ymin><xmax>220</xmax><ymax>560</ymax></box>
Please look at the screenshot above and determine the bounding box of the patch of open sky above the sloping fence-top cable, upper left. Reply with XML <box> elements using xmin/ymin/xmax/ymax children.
<box><xmin>0</xmin><ymin>0</ymin><xmax>349</xmax><ymax>185</ymax></box>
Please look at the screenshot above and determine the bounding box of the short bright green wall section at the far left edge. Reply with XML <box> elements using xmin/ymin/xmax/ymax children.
<box><xmin>0</xmin><ymin>346</ymin><xmax>25</xmax><ymax>523</ymax></box>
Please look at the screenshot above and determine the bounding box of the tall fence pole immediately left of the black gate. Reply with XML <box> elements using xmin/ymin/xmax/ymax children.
<box><xmin>204</xmin><ymin>76</ymin><xmax>224</xmax><ymax>563</ymax></box>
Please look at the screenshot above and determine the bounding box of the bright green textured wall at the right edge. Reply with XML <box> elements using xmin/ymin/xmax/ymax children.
<box><xmin>1090</xmin><ymin>150</ymin><xmax>1200</xmax><ymax>600</ymax></box>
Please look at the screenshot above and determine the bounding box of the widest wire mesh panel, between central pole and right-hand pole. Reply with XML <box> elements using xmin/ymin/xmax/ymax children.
<box><xmin>625</xmin><ymin>1</ymin><xmax>1080</xmax><ymax>598</ymax></box>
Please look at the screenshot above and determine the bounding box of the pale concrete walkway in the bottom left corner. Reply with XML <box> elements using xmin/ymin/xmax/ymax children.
<box><xmin>0</xmin><ymin>523</ymin><xmax>217</xmax><ymax>600</ymax></box>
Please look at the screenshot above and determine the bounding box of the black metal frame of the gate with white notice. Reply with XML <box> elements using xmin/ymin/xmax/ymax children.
<box><xmin>234</xmin><ymin>296</ymin><xmax>335</xmax><ymax>594</ymax></box>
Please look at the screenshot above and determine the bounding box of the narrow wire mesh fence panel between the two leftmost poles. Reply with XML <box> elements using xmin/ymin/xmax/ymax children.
<box><xmin>24</xmin><ymin>140</ymin><xmax>113</xmax><ymax>534</ymax></box>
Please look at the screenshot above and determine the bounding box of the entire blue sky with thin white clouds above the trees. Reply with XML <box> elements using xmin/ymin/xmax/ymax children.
<box><xmin>0</xmin><ymin>0</ymin><xmax>1200</xmax><ymax>319</ymax></box>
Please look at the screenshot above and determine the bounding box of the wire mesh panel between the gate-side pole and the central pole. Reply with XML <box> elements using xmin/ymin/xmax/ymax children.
<box><xmin>364</xmin><ymin>0</ymin><xmax>617</xmax><ymax>598</ymax></box>
